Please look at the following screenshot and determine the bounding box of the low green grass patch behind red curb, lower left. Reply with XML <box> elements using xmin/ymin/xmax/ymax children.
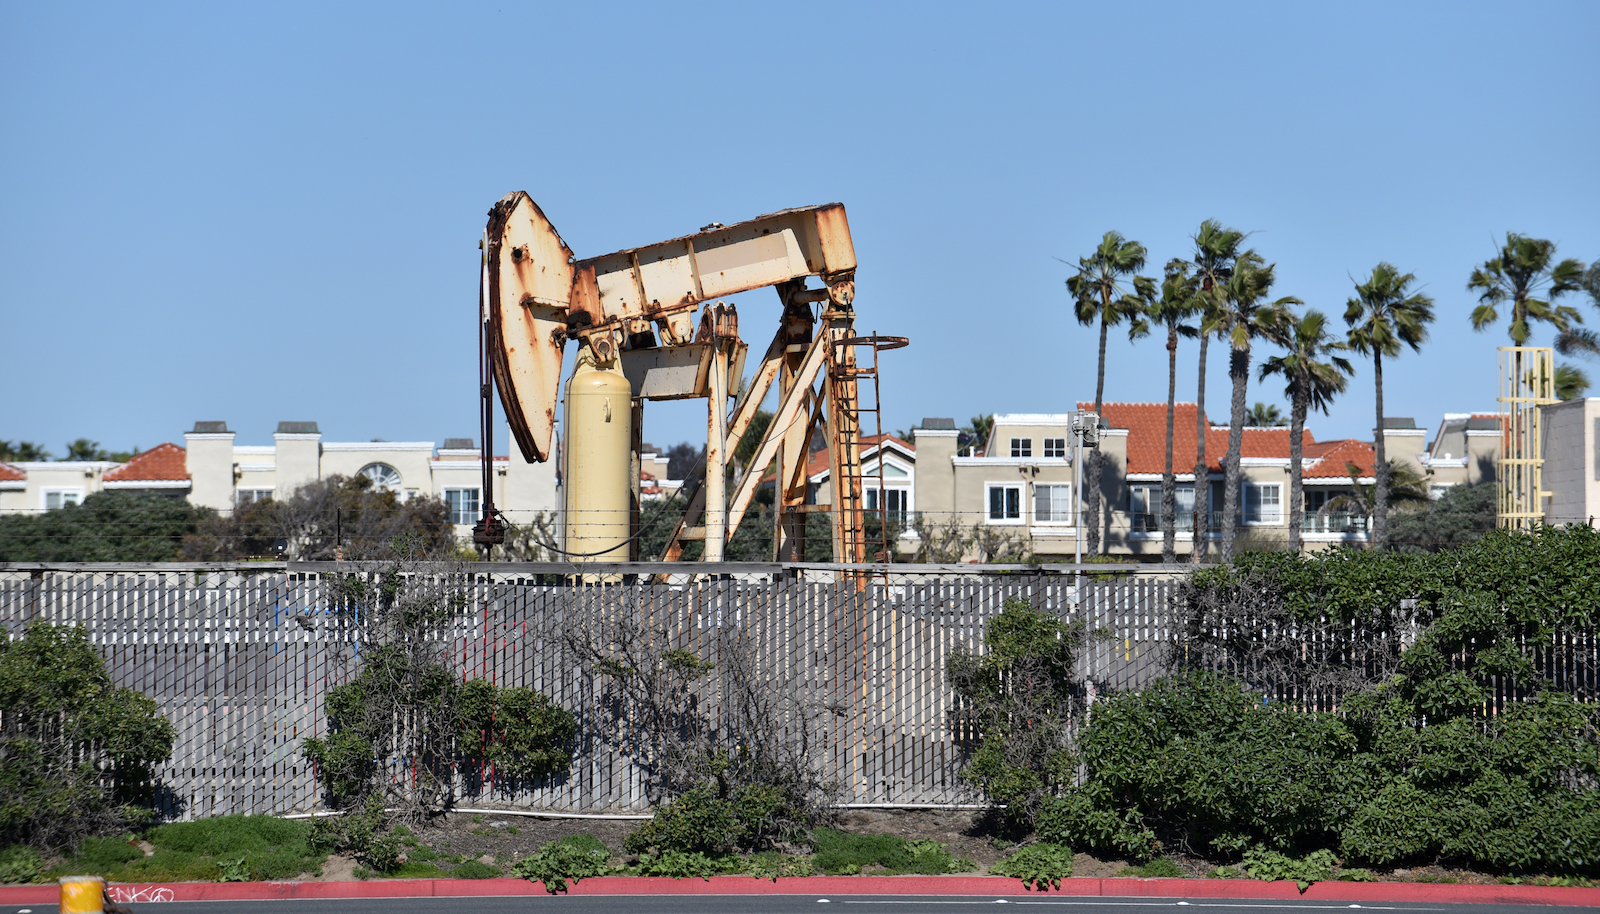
<box><xmin>46</xmin><ymin>815</ymin><xmax>326</xmax><ymax>882</ymax></box>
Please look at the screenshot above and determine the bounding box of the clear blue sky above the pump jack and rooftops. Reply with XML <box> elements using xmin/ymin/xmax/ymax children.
<box><xmin>0</xmin><ymin>0</ymin><xmax>1600</xmax><ymax>453</ymax></box>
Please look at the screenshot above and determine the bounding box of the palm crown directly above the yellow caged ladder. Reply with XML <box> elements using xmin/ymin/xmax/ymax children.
<box><xmin>1467</xmin><ymin>232</ymin><xmax>1584</xmax><ymax>346</ymax></box>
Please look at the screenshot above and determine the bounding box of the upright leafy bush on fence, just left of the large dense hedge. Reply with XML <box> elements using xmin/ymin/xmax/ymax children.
<box><xmin>946</xmin><ymin>600</ymin><xmax>1083</xmax><ymax>831</ymax></box>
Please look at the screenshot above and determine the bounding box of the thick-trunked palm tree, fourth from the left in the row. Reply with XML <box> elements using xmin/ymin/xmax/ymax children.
<box><xmin>1222</xmin><ymin>251</ymin><xmax>1304</xmax><ymax>562</ymax></box>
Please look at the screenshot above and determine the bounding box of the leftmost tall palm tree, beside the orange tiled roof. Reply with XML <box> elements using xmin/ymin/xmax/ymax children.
<box><xmin>1067</xmin><ymin>232</ymin><xmax>1155</xmax><ymax>555</ymax></box>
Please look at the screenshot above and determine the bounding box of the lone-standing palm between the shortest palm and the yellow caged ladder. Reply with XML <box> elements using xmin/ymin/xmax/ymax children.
<box><xmin>1344</xmin><ymin>263</ymin><xmax>1434</xmax><ymax>549</ymax></box>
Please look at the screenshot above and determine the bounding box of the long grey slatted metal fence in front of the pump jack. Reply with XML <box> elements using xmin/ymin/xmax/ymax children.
<box><xmin>0</xmin><ymin>563</ymin><xmax>1178</xmax><ymax>818</ymax></box>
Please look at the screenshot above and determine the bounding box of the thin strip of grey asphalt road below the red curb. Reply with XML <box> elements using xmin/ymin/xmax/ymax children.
<box><xmin>0</xmin><ymin>895</ymin><xmax>1592</xmax><ymax>914</ymax></box>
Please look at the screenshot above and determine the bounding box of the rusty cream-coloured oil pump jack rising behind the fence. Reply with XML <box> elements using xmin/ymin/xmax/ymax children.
<box><xmin>474</xmin><ymin>190</ymin><xmax>907</xmax><ymax>563</ymax></box>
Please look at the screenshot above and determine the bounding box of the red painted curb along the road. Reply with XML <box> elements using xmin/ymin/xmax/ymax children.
<box><xmin>0</xmin><ymin>876</ymin><xmax>1600</xmax><ymax>908</ymax></box>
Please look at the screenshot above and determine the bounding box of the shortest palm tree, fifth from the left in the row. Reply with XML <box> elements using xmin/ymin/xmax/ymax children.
<box><xmin>1261</xmin><ymin>311</ymin><xmax>1355</xmax><ymax>552</ymax></box>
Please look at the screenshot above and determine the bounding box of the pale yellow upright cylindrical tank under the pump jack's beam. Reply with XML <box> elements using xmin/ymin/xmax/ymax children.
<box><xmin>562</xmin><ymin>347</ymin><xmax>634</xmax><ymax>562</ymax></box>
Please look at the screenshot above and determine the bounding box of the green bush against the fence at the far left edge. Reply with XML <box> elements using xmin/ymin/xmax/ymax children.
<box><xmin>0</xmin><ymin>623</ymin><xmax>174</xmax><ymax>850</ymax></box>
